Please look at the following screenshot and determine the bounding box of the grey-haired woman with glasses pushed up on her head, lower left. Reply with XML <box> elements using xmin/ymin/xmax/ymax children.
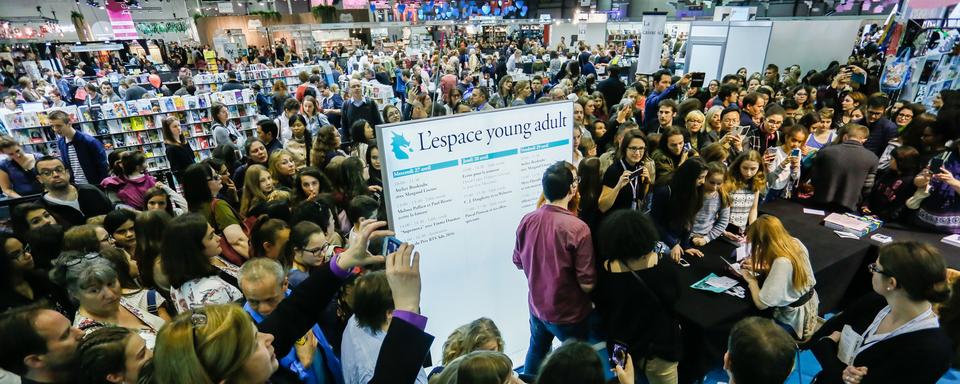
<box><xmin>50</xmin><ymin>251</ymin><xmax>165</xmax><ymax>349</ymax></box>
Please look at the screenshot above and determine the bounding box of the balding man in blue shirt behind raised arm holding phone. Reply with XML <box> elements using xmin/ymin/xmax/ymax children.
<box><xmin>239</xmin><ymin>257</ymin><xmax>343</xmax><ymax>384</ymax></box>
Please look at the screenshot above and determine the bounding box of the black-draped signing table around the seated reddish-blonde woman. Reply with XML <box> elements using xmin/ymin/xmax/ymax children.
<box><xmin>674</xmin><ymin>202</ymin><xmax>876</xmax><ymax>382</ymax></box>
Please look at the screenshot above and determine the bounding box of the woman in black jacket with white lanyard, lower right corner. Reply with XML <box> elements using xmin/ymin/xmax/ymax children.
<box><xmin>810</xmin><ymin>241</ymin><xmax>952</xmax><ymax>384</ymax></box>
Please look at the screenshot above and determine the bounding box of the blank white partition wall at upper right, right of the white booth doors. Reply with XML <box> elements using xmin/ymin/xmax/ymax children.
<box><xmin>765</xmin><ymin>18</ymin><xmax>882</xmax><ymax>73</ymax></box>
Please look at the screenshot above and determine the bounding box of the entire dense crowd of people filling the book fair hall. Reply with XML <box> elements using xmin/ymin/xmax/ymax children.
<box><xmin>0</xmin><ymin>32</ymin><xmax>960</xmax><ymax>384</ymax></box>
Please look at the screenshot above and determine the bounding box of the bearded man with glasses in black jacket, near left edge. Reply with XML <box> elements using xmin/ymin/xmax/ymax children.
<box><xmin>37</xmin><ymin>156</ymin><xmax>113</xmax><ymax>229</ymax></box>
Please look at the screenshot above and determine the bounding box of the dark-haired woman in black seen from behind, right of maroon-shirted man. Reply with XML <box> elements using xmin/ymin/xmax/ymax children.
<box><xmin>594</xmin><ymin>210</ymin><xmax>682</xmax><ymax>384</ymax></box>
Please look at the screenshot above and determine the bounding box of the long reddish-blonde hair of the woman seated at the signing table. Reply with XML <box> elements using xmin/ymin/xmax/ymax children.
<box><xmin>747</xmin><ymin>215</ymin><xmax>811</xmax><ymax>291</ymax></box>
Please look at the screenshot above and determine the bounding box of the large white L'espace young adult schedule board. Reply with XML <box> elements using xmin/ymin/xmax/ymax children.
<box><xmin>377</xmin><ymin>101</ymin><xmax>573</xmax><ymax>365</ymax></box>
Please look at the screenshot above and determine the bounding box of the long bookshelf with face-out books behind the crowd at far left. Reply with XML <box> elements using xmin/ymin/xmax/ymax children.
<box><xmin>3</xmin><ymin>89</ymin><xmax>258</xmax><ymax>172</ymax></box>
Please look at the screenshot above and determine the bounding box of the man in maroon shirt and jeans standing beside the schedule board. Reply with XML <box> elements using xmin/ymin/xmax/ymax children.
<box><xmin>513</xmin><ymin>161</ymin><xmax>597</xmax><ymax>376</ymax></box>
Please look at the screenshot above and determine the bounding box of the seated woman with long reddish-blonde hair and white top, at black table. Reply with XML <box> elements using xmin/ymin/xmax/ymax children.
<box><xmin>742</xmin><ymin>215</ymin><xmax>820</xmax><ymax>340</ymax></box>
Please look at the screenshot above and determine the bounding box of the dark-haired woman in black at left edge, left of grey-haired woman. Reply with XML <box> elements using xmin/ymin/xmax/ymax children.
<box><xmin>0</xmin><ymin>233</ymin><xmax>77</xmax><ymax>319</ymax></box>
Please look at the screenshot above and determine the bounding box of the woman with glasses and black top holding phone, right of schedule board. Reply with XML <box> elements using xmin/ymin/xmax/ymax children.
<box><xmin>598</xmin><ymin>129</ymin><xmax>656</xmax><ymax>213</ymax></box>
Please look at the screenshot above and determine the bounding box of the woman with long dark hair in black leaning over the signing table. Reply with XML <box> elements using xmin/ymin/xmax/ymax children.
<box><xmin>650</xmin><ymin>157</ymin><xmax>707</xmax><ymax>263</ymax></box>
